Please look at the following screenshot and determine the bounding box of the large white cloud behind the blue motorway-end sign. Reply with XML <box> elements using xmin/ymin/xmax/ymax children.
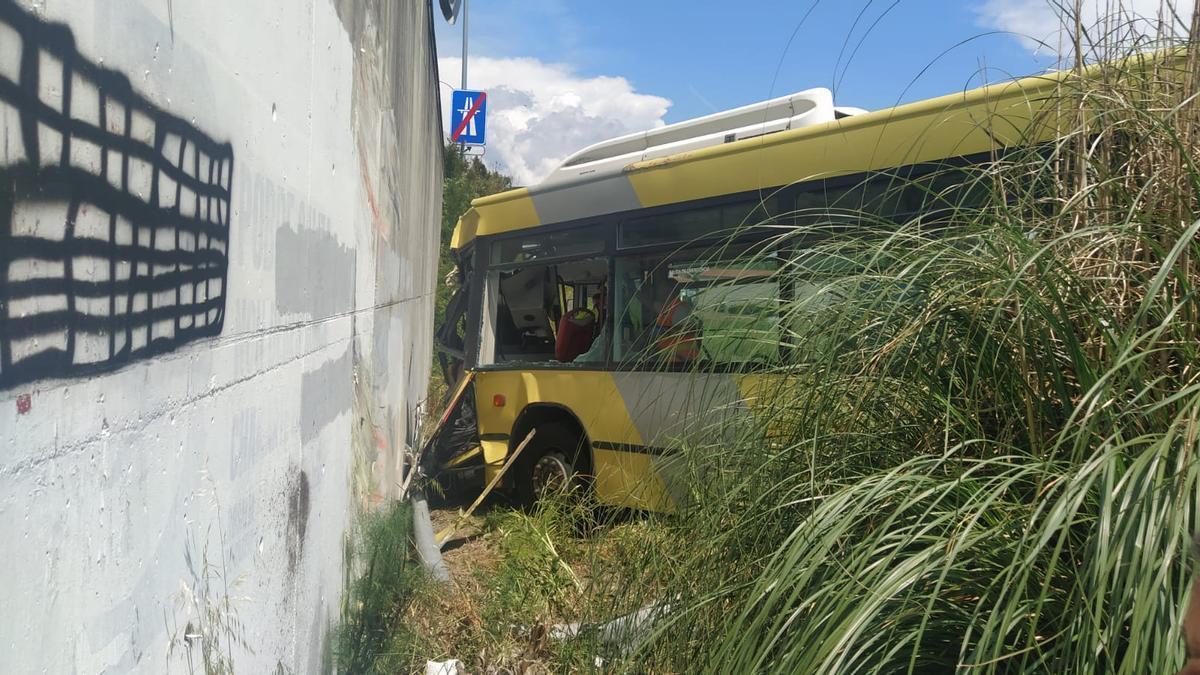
<box><xmin>438</xmin><ymin>56</ymin><xmax>671</xmax><ymax>185</ymax></box>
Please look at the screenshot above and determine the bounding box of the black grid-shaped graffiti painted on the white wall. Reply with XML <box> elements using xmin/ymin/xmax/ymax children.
<box><xmin>0</xmin><ymin>0</ymin><xmax>233</xmax><ymax>390</ymax></box>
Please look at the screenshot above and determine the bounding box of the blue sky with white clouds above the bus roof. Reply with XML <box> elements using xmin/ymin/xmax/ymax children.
<box><xmin>434</xmin><ymin>0</ymin><xmax>1192</xmax><ymax>185</ymax></box>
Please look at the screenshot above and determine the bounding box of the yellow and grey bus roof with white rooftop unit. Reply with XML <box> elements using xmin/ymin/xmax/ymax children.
<box><xmin>450</xmin><ymin>54</ymin><xmax>1160</xmax><ymax>250</ymax></box>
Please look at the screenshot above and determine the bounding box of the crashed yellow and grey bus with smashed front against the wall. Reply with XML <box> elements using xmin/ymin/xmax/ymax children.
<box><xmin>421</xmin><ymin>73</ymin><xmax>1070</xmax><ymax>510</ymax></box>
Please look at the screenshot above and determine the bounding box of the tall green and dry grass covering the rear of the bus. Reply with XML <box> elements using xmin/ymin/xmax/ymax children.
<box><xmin>556</xmin><ymin>6</ymin><xmax>1200</xmax><ymax>673</ymax></box>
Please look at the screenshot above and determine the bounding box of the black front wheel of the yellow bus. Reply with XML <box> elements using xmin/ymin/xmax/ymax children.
<box><xmin>512</xmin><ymin>422</ymin><xmax>587</xmax><ymax>504</ymax></box>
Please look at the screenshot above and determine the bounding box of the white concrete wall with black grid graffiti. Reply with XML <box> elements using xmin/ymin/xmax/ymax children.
<box><xmin>0</xmin><ymin>0</ymin><xmax>442</xmax><ymax>673</ymax></box>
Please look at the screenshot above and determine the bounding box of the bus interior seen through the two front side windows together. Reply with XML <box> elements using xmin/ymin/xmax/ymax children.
<box><xmin>480</xmin><ymin>241</ymin><xmax>784</xmax><ymax>368</ymax></box>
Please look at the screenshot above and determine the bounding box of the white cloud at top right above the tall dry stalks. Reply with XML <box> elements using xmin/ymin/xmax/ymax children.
<box><xmin>978</xmin><ymin>0</ymin><xmax>1193</xmax><ymax>55</ymax></box>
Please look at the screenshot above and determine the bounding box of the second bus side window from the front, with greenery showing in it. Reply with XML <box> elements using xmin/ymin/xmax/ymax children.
<box><xmin>612</xmin><ymin>251</ymin><xmax>781</xmax><ymax>370</ymax></box>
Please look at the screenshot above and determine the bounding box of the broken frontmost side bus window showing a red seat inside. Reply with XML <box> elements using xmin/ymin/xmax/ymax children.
<box><xmin>479</xmin><ymin>258</ymin><xmax>608</xmax><ymax>365</ymax></box>
